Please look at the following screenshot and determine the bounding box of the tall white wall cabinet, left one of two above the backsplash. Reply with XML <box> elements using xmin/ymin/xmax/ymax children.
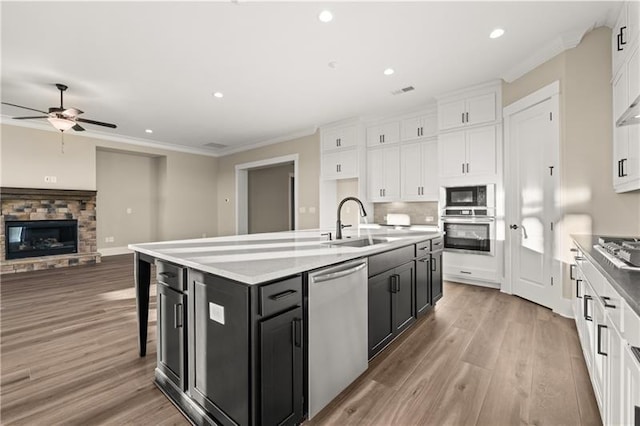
<box><xmin>367</xmin><ymin>145</ymin><xmax>400</xmax><ymax>202</ymax></box>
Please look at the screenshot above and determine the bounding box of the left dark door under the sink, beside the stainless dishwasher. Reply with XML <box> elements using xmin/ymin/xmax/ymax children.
<box><xmin>368</xmin><ymin>270</ymin><xmax>395</xmax><ymax>359</ymax></box>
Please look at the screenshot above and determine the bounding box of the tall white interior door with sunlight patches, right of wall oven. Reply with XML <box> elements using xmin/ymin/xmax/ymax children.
<box><xmin>507</xmin><ymin>93</ymin><xmax>560</xmax><ymax>308</ymax></box>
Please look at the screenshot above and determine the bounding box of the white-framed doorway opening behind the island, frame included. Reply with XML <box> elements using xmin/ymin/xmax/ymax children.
<box><xmin>236</xmin><ymin>154</ymin><xmax>298</xmax><ymax>235</ymax></box>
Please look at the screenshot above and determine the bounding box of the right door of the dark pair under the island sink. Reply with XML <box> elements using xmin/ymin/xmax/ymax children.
<box><xmin>393</xmin><ymin>262</ymin><xmax>416</xmax><ymax>334</ymax></box>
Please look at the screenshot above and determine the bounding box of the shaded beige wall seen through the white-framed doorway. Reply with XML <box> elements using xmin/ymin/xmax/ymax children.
<box><xmin>248</xmin><ymin>163</ymin><xmax>293</xmax><ymax>234</ymax></box>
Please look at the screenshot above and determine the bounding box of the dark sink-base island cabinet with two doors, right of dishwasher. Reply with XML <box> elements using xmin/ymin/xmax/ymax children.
<box><xmin>368</xmin><ymin>246</ymin><xmax>415</xmax><ymax>359</ymax></box>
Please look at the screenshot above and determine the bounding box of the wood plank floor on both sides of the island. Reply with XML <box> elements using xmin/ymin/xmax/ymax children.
<box><xmin>0</xmin><ymin>255</ymin><xmax>600</xmax><ymax>425</ymax></box>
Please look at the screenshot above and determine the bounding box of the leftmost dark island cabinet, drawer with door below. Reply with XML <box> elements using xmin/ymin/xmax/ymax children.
<box><xmin>156</xmin><ymin>262</ymin><xmax>187</xmax><ymax>390</ymax></box>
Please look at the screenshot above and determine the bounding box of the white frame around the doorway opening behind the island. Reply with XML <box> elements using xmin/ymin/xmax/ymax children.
<box><xmin>236</xmin><ymin>154</ymin><xmax>300</xmax><ymax>235</ymax></box>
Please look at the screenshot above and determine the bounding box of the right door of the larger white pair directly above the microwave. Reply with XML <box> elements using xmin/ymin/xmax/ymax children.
<box><xmin>465</xmin><ymin>126</ymin><xmax>496</xmax><ymax>176</ymax></box>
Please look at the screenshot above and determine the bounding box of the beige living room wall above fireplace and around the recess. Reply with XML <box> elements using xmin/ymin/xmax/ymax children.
<box><xmin>0</xmin><ymin>124</ymin><xmax>218</xmax><ymax>247</ymax></box>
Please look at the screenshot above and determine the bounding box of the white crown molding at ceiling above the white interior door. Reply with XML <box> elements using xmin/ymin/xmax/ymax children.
<box><xmin>501</xmin><ymin>24</ymin><xmax>596</xmax><ymax>83</ymax></box>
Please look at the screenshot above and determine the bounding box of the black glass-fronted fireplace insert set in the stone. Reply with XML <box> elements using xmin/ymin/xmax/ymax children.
<box><xmin>5</xmin><ymin>220</ymin><xmax>78</xmax><ymax>260</ymax></box>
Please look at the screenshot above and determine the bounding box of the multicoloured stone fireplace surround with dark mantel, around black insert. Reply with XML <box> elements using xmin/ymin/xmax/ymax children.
<box><xmin>0</xmin><ymin>187</ymin><xmax>100</xmax><ymax>274</ymax></box>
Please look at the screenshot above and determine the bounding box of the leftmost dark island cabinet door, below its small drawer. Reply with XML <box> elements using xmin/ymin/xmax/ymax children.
<box><xmin>158</xmin><ymin>284</ymin><xmax>186</xmax><ymax>391</ymax></box>
